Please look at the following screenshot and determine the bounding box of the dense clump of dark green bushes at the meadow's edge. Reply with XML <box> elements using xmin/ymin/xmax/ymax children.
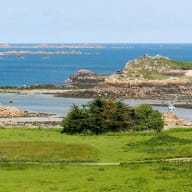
<box><xmin>62</xmin><ymin>98</ymin><xmax>164</xmax><ymax>134</ymax></box>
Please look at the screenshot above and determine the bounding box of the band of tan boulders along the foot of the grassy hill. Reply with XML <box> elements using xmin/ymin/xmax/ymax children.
<box><xmin>103</xmin><ymin>79</ymin><xmax>192</xmax><ymax>99</ymax></box>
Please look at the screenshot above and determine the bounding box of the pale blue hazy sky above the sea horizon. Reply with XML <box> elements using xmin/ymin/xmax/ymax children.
<box><xmin>0</xmin><ymin>0</ymin><xmax>192</xmax><ymax>43</ymax></box>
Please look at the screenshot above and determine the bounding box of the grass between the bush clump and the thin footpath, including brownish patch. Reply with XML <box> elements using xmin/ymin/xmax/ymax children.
<box><xmin>0</xmin><ymin>129</ymin><xmax>192</xmax><ymax>162</ymax></box>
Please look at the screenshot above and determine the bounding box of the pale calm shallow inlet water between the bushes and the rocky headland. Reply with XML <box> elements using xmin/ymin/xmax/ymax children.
<box><xmin>0</xmin><ymin>93</ymin><xmax>192</xmax><ymax>121</ymax></box>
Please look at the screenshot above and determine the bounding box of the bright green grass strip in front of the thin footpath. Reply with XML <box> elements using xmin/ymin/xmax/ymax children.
<box><xmin>0</xmin><ymin>162</ymin><xmax>192</xmax><ymax>192</ymax></box>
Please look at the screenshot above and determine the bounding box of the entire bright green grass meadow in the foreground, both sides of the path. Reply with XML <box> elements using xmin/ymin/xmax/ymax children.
<box><xmin>0</xmin><ymin>128</ymin><xmax>192</xmax><ymax>192</ymax></box>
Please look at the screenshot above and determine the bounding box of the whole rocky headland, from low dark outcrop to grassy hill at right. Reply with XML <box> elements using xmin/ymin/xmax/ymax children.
<box><xmin>54</xmin><ymin>55</ymin><xmax>192</xmax><ymax>100</ymax></box>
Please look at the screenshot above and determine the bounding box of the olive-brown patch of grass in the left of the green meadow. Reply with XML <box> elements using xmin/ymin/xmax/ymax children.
<box><xmin>0</xmin><ymin>141</ymin><xmax>98</xmax><ymax>162</ymax></box>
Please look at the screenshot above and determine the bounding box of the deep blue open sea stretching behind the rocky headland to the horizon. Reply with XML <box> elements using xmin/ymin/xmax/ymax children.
<box><xmin>0</xmin><ymin>44</ymin><xmax>192</xmax><ymax>86</ymax></box>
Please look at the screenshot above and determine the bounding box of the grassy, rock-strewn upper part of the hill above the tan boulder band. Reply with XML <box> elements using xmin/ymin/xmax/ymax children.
<box><xmin>122</xmin><ymin>56</ymin><xmax>192</xmax><ymax>80</ymax></box>
